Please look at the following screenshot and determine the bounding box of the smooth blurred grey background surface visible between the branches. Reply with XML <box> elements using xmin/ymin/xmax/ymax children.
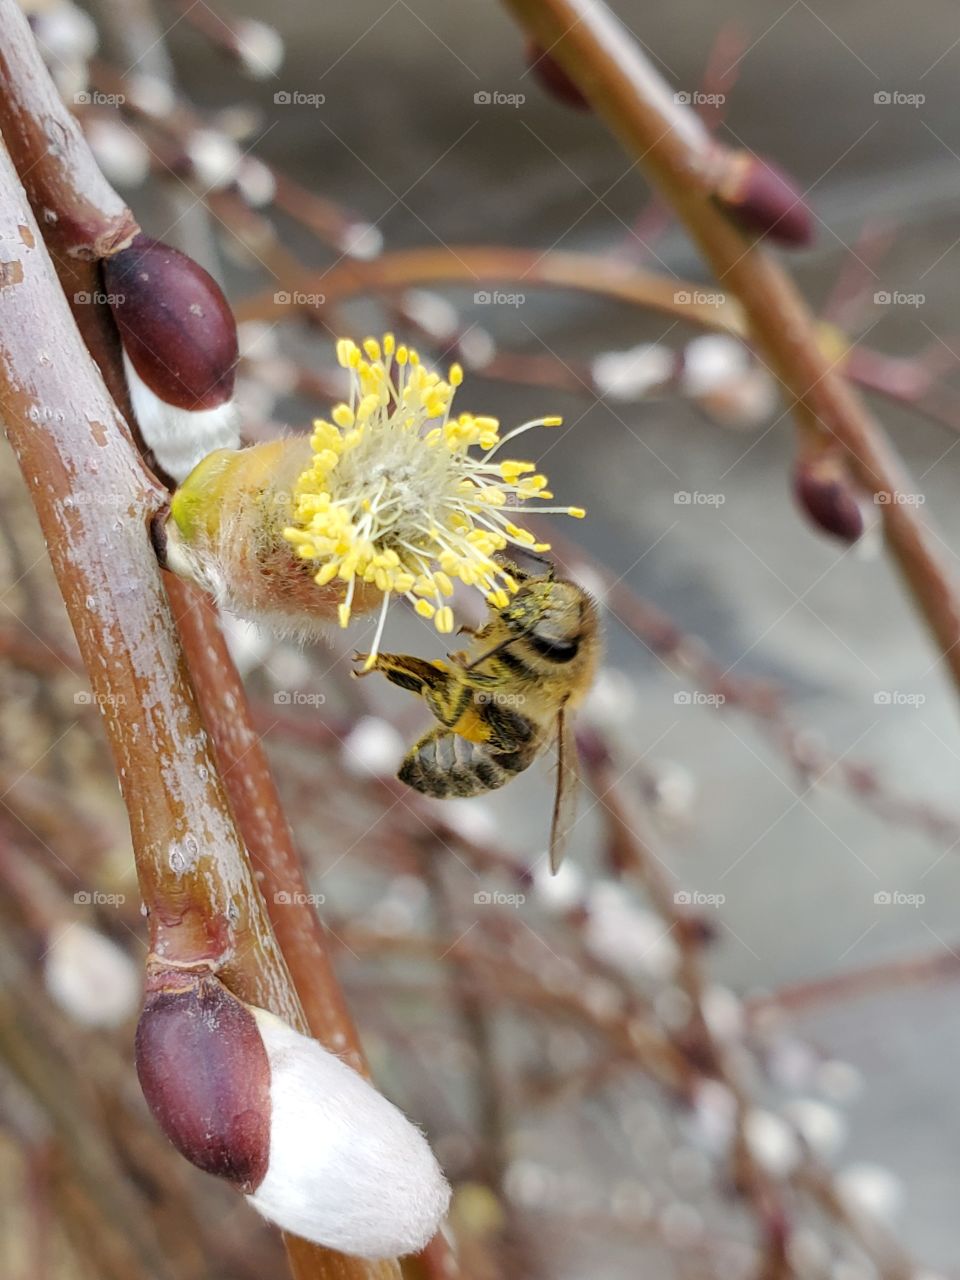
<box><xmin>160</xmin><ymin>0</ymin><xmax>960</xmax><ymax>1268</ymax></box>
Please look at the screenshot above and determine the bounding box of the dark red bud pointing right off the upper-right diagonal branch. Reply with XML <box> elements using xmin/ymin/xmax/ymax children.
<box><xmin>714</xmin><ymin>151</ymin><xmax>814</xmax><ymax>248</ymax></box>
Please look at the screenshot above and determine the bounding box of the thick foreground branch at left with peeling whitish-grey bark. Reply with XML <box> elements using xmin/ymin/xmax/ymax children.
<box><xmin>0</xmin><ymin>115</ymin><xmax>398</xmax><ymax>1280</ymax></box>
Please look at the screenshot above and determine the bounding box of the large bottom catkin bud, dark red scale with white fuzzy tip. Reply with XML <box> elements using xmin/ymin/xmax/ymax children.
<box><xmin>137</xmin><ymin>973</ymin><xmax>449</xmax><ymax>1258</ymax></box>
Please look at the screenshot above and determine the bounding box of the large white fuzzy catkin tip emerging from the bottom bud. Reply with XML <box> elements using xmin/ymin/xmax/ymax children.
<box><xmin>247</xmin><ymin>1009</ymin><xmax>449</xmax><ymax>1258</ymax></box>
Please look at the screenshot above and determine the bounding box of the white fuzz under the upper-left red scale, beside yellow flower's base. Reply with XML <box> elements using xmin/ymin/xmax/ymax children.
<box><xmin>123</xmin><ymin>352</ymin><xmax>239</xmax><ymax>484</ymax></box>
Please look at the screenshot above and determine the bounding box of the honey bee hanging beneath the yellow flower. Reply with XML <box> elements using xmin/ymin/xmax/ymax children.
<box><xmin>355</xmin><ymin>564</ymin><xmax>600</xmax><ymax>873</ymax></box>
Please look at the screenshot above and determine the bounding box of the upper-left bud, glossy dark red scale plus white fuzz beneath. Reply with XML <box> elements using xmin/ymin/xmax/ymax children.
<box><xmin>104</xmin><ymin>236</ymin><xmax>238</xmax><ymax>480</ymax></box>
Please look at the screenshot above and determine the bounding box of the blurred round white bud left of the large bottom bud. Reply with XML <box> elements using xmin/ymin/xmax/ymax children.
<box><xmin>44</xmin><ymin>924</ymin><xmax>141</xmax><ymax>1027</ymax></box>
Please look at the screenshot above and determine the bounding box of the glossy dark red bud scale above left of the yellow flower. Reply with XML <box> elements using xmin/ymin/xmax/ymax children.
<box><xmin>102</xmin><ymin>234</ymin><xmax>238</xmax><ymax>410</ymax></box>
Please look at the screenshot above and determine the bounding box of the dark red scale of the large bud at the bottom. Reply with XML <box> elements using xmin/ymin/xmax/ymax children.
<box><xmin>136</xmin><ymin>973</ymin><xmax>270</xmax><ymax>1193</ymax></box>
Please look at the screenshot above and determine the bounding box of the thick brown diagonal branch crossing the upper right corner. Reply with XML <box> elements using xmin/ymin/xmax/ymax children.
<box><xmin>506</xmin><ymin>0</ymin><xmax>960</xmax><ymax>706</ymax></box>
